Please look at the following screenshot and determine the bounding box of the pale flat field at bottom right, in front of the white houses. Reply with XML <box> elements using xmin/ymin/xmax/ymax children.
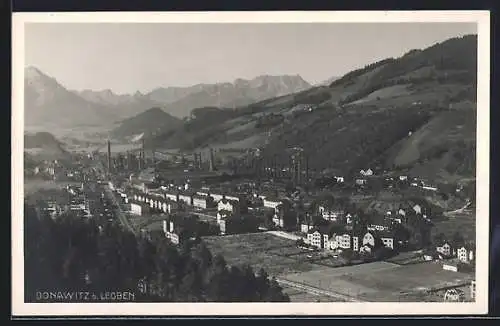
<box><xmin>282</xmin><ymin>262</ymin><xmax>472</xmax><ymax>301</ymax></box>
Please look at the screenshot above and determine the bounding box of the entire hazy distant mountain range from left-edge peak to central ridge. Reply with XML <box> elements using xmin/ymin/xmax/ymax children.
<box><xmin>24</xmin><ymin>66</ymin><xmax>311</xmax><ymax>127</ymax></box>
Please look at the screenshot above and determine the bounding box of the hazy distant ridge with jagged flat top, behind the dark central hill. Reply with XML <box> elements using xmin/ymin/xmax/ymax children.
<box><xmin>158</xmin><ymin>76</ymin><xmax>311</xmax><ymax>117</ymax></box>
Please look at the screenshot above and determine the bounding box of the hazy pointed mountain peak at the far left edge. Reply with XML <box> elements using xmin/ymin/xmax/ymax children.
<box><xmin>24</xmin><ymin>67</ymin><xmax>116</xmax><ymax>127</ymax></box>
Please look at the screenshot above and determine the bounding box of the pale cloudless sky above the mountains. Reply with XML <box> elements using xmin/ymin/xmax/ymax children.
<box><xmin>25</xmin><ymin>23</ymin><xmax>477</xmax><ymax>94</ymax></box>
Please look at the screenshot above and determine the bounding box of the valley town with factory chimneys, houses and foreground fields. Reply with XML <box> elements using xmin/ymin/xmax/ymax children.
<box><xmin>25</xmin><ymin>136</ymin><xmax>475</xmax><ymax>302</ymax></box>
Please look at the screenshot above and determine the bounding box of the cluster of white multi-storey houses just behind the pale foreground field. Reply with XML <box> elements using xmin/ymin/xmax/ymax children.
<box><xmin>263</xmin><ymin>194</ymin><xmax>438</xmax><ymax>258</ymax></box>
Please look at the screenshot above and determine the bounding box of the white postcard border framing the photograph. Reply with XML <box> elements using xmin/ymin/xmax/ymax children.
<box><xmin>11</xmin><ymin>11</ymin><xmax>490</xmax><ymax>316</ymax></box>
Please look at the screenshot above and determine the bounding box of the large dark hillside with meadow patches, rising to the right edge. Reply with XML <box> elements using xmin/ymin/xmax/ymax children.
<box><xmin>153</xmin><ymin>35</ymin><xmax>477</xmax><ymax>181</ymax></box>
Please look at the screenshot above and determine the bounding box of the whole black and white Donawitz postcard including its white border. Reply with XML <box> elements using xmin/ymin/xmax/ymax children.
<box><xmin>12</xmin><ymin>11</ymin><xmax>490</xmax><ymax>315</ymax></box>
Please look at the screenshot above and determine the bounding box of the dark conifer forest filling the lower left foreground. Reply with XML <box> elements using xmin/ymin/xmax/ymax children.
<box><xmin>24</xmin><ymin>205</ymin><xmax>289</xmax><ymax>302</ymax></box>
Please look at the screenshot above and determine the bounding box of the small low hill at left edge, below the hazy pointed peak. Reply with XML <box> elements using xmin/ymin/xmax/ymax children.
<box><xmin>24</xmin><ymin>132</ymin><xmax>69</xmax><ymax>161</ymax></box>
